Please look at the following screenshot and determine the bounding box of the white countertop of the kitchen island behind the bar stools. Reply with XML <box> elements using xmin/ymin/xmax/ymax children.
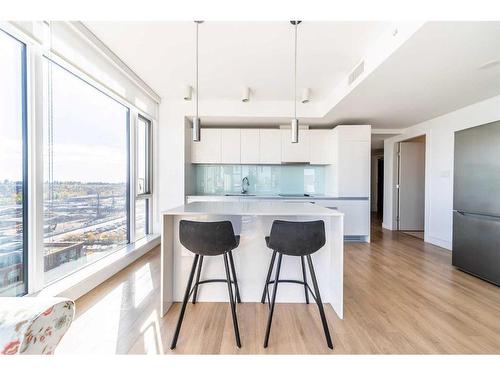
<box><xmin>162</xmin><ymin>201</ymin><xmax>344</xmax><ymax>216</ymax></box>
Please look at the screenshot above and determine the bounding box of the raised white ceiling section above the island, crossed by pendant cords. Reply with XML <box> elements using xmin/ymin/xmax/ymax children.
<box><xmin>85</xmin><ymin>21</ymin><xmax>388</xmax><ymax>101</ymax></box>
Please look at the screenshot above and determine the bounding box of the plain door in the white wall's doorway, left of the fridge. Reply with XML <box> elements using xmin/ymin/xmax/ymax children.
<box><xmin>398</xmin><ymin>142</ymin><xmax>425</xmax><ymax>231</ymax></box>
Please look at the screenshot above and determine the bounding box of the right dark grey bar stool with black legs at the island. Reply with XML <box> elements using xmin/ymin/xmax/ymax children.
<box><xmin>261</xmin><ymin>220</ymin><xmax>333</xmax><ymax>349</ymax></box>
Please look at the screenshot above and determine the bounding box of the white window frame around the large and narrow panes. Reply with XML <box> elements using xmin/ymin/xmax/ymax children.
<box><xmin>0</xmin><ymin>21</ymin><xmax>160</xmax><ymax>295</ymax></box>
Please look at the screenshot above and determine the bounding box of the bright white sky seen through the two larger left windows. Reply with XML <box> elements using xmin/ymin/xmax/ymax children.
<box><xmin>0</xmin><ymin>33</ymin><xmax>128</xmax><ymax>182</ymax></box>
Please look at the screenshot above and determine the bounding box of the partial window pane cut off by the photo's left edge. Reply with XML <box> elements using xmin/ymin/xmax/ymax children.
<box><xmin>0</xmin><ymin>30</ymin><xmax>28</xmax><ymax>297</ymax></box>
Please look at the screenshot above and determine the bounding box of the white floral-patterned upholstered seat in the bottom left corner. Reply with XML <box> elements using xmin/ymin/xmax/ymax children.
<box><xmin>0</xmin><ymin>297</ymin><xmax>75</xmax><ymax>355</ymax></box>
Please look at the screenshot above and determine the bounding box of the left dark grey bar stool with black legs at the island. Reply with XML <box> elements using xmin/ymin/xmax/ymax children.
<box><xmin>170</xmin><ymin>220</ymin><xmax>241</xmax><ymax>349</ymax></box>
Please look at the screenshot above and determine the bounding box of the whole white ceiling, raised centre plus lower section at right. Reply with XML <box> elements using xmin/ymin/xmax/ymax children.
<box><xmin>85</xmin><ymin>21</ymin><xmax>500</xmax><ymax>129</ymax></box>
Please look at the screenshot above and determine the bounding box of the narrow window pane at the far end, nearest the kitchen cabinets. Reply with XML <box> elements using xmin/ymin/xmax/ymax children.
<box><xmin>135</xmin><ymin>116</ymin><xmax>151</xmax><ymax>240</ymax></box>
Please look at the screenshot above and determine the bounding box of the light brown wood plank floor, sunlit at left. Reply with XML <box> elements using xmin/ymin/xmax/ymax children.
<box><xmin>56</xmin><ymin>219</ymin><xmax>500</xmax><ymax>354</ymax></box>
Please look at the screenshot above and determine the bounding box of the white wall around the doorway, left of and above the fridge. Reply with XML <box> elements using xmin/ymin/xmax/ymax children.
<box><xmin>382</xmin><ymin>96</ymin><xmax>500</xmax><ymax>250</ymax></box>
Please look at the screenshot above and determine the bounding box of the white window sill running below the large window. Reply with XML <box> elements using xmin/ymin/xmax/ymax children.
<box><xmin>30</xmin><ymin>234</ymin><xmax>161</xmax><ymax>300</ymax></box>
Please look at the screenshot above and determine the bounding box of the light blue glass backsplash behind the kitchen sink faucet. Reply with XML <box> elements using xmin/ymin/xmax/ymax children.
<box><xmin>195</xmin><ymin>164</ymin><xmax>325</xmax><ymax>195</ymax></box>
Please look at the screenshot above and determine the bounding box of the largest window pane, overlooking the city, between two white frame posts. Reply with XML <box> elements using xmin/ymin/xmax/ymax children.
<box><xmin>43</xmin><ymin>59</ymin><xmax>130</xmax><ymax>283</ymax></box>
